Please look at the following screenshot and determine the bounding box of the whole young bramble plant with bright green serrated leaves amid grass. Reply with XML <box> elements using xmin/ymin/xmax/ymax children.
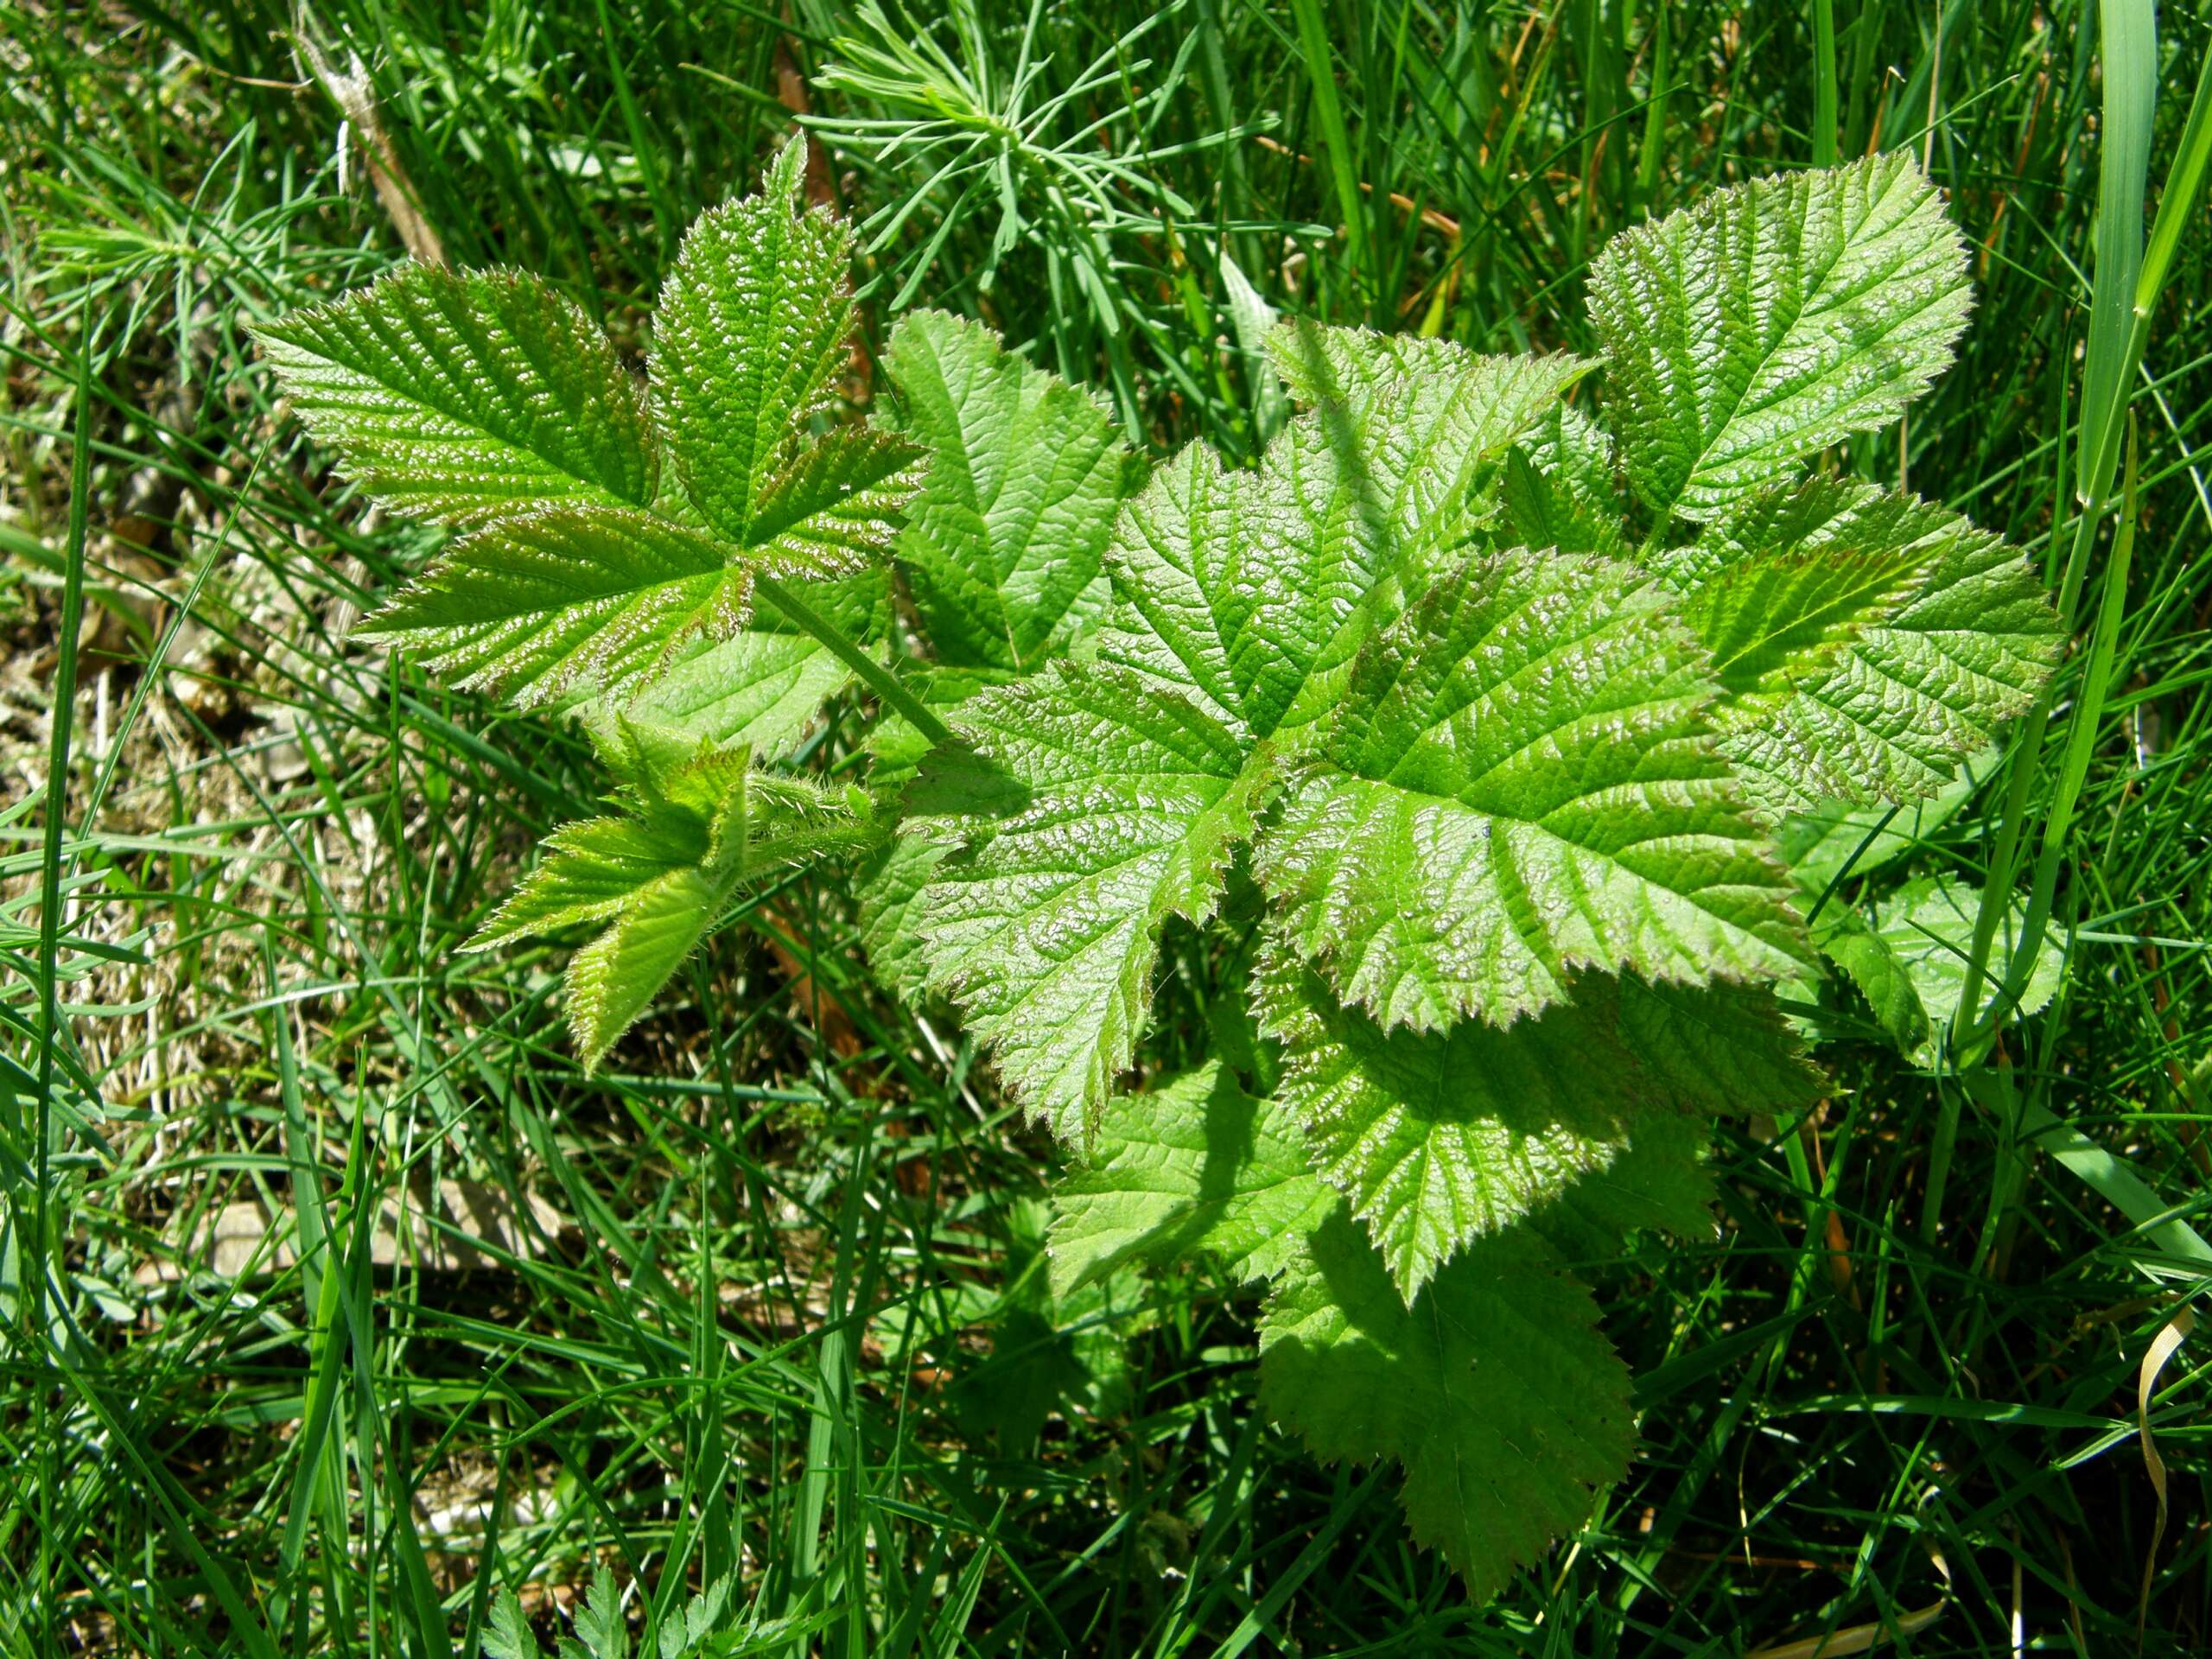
<box><xmin>265</xmin><ymin>142</ymin><xmax>2059</xmax><ymax>1595</ymax></box>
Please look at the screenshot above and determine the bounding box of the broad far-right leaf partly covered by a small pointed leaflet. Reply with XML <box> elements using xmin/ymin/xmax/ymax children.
<box><xmin>1659</xmin><ymin>480</ymin><xmax>2062</xmax><ymax>818</ymax></box>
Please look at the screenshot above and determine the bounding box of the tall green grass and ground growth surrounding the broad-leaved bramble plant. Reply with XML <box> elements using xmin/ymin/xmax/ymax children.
<box><xmin>0</xmin><ymin>0</ymin><xmax>2212</xmax><ymax>1656</ymax></box>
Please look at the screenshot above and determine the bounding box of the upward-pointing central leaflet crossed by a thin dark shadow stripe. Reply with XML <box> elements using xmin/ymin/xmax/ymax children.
<box><xmin>1099</xmin><ymin>345</ymin><xmax>1588</xmax><ymax>736</ymax></box>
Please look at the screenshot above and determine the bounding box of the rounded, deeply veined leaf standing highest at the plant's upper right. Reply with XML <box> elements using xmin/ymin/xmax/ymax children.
<box><xmin>1591</xmin><ymin>153</ymin><xmax>1974</xmax><ymax>531</ymax></box>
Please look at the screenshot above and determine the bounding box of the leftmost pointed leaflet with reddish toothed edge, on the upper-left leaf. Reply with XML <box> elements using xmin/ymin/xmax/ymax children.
<box><xmin>254</xmin><ymin>265</ymin><xmax>659</xmax><ymax>524</ymax></box>
